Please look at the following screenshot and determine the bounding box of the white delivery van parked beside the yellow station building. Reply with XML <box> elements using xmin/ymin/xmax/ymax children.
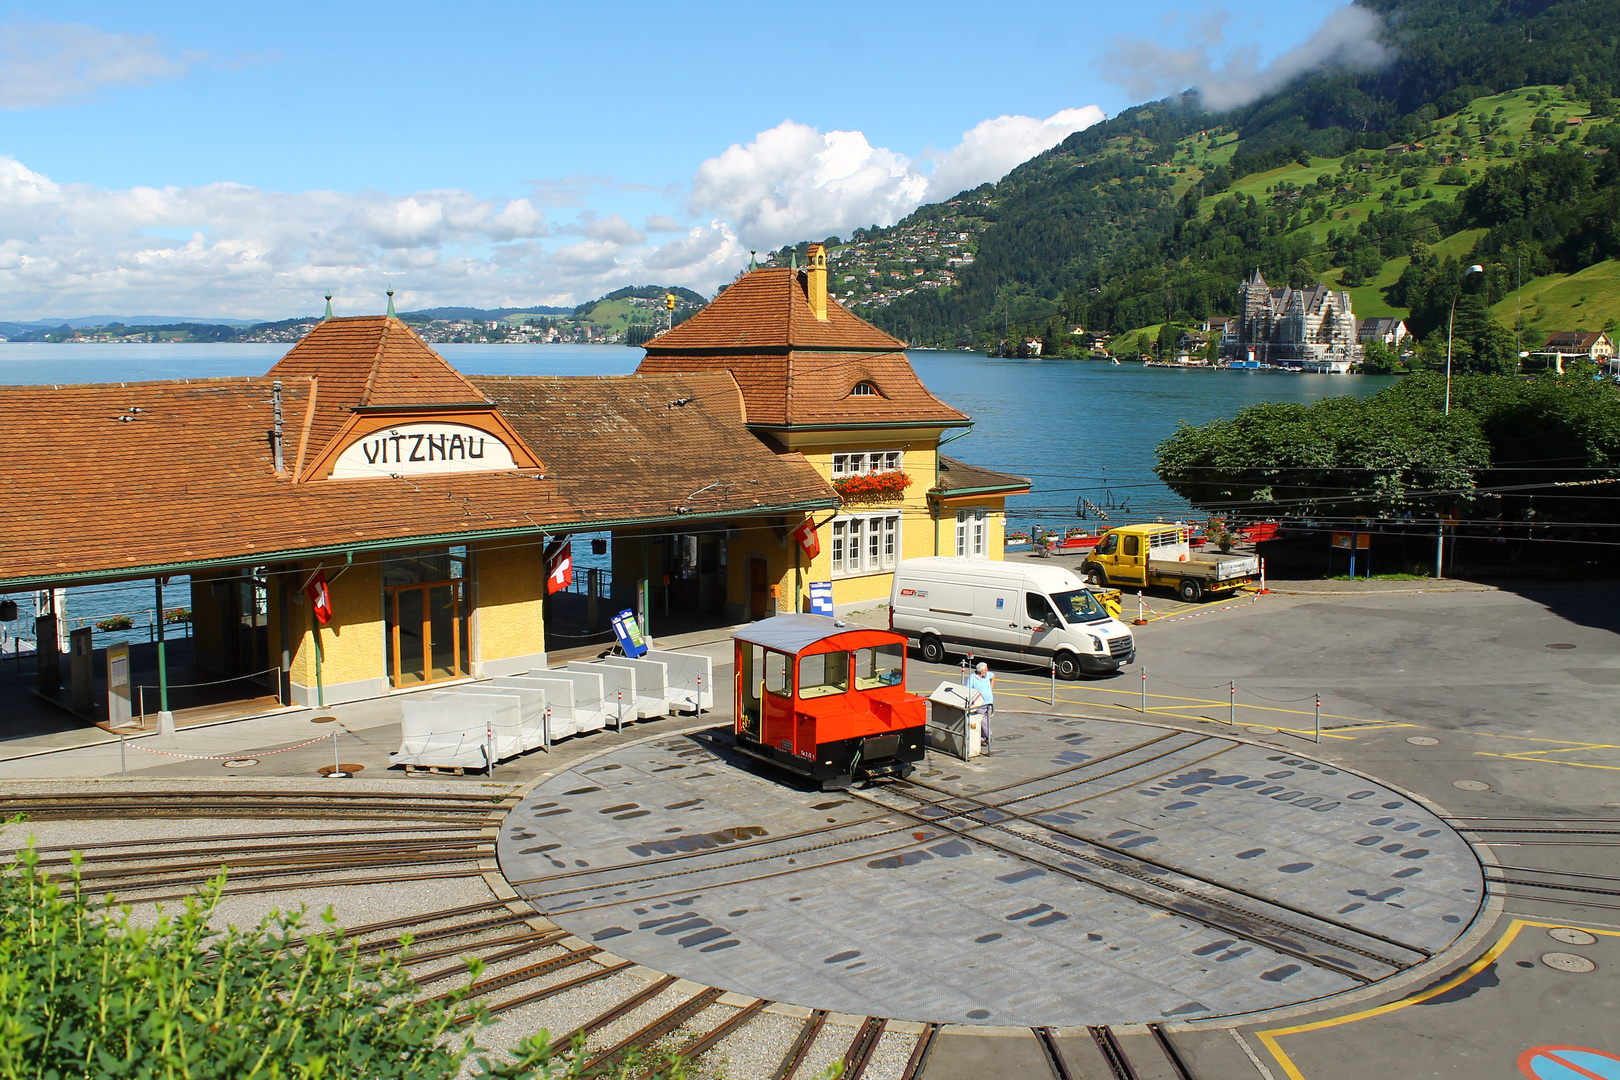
<box><xmin>889</xmin><ymin>557</ymin><xmax>1136</xmax><ymax>678</ymax></box>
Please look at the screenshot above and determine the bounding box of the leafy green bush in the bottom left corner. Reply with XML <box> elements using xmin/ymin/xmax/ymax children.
<box><xmin>0</xmin><ymin>844</ymin><xmax>685</xmax><ymax>1080</ymax></box>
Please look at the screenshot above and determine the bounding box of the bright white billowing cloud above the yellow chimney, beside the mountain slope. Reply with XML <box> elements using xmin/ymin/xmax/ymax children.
<box><xmin>687</xmin><ymin>105</ymin><xmax>1103</xmax><ymax>249</ymax></box>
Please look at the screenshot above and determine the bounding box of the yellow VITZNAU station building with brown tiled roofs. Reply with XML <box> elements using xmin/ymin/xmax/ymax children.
<box><xmin>0</xmin><ymin>251</ymin><xmax>1029</xmax><ymax>719</ymax></box>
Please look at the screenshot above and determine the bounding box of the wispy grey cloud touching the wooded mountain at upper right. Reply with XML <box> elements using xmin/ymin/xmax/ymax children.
<box><xmin>1103</xmin><ymin>6</ymin><xmax>1393</xmax><ymax>112</ymax></box>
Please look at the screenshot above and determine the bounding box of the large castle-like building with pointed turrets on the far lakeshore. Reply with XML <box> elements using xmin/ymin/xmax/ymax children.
<box><xmin>1220</xmin><ymin>270</ymin><xmax>1361</xmax><ymax>372</ymax></box>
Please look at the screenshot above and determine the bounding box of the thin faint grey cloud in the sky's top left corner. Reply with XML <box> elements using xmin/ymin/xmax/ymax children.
<box><xmin>0</xmin><ymin>21</ymin><xmax>207</xmax><ymax>108</ymax></box>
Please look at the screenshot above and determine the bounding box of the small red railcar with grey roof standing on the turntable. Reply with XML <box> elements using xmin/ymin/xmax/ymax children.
<box><xmin>732</xmin><ymin>615</ymin><xmax>928</xmax><ymax>790</ymax></box>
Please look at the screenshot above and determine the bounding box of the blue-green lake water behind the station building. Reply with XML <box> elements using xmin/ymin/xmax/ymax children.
<box><xmin>0</xmin><ymin>343</ymin><xmax>1393</xmax><ymax>643</ymax></box>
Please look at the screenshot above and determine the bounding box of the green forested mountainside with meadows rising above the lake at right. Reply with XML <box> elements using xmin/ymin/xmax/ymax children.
<box><xmin>784</xmin><ymin>0</ymin><xmax>1620</xmax><ymax>356</ymax></box>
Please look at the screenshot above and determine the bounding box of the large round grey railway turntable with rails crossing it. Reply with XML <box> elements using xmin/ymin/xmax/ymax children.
<box><xmin>497</xmin><ymin>712</ymin><xmax>1486</xmax><ymax>1028</ymax></box>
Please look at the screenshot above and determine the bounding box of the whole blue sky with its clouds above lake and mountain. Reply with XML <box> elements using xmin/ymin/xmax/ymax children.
<box><xmin>0</xmin><ymin>0</ymin><xmax>1367</xmax><ymax>319</ymax></box>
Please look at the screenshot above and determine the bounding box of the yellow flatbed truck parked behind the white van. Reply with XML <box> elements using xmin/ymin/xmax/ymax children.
<box><xmin>1081</xmin><ymin>525</ymin><xmax>1260</xmax><ymax>604</ymax></box>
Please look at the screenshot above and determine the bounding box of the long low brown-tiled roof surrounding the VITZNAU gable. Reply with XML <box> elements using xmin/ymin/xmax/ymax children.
<box><xmin>0</xmin><ymin>372</ymin><xmax>836</xmax><ymax>583</ymax></box>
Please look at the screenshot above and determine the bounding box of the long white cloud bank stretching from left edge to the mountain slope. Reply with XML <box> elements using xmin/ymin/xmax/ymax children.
<box><xmin>0</xmin><ymin>97</ymin><xmax>1102</xmax><ymax>319</ymax></box>
